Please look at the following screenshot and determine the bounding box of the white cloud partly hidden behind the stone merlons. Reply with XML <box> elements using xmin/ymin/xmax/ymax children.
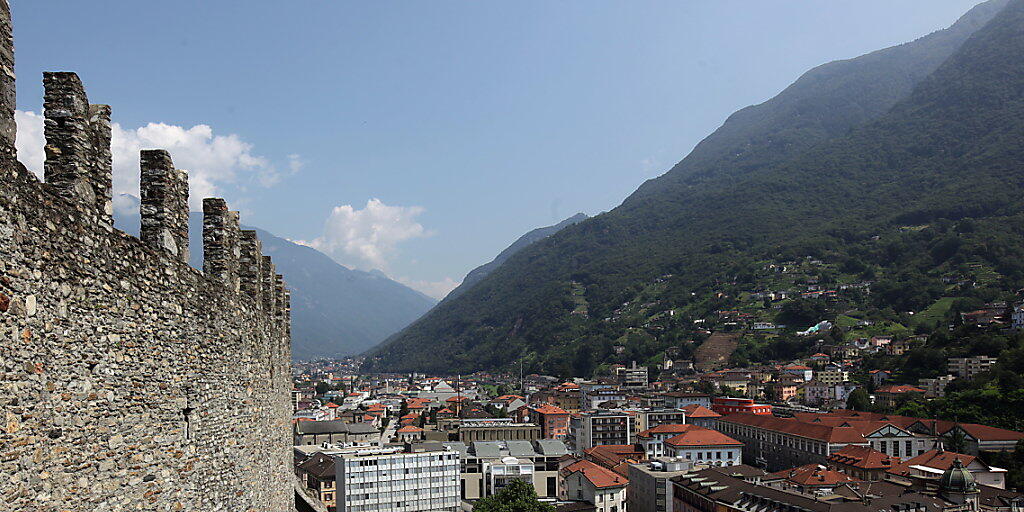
<box><xmin>15</xmin><ymin>111</ymin><xmax>292</xmax><ymax>210</ymax></box>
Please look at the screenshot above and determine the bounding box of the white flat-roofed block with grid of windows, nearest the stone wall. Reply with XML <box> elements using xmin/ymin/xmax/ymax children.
<box><xmin>335</xmin><ymin>449</ymin><xmax>461</xmax><ymax>512</ymax></box>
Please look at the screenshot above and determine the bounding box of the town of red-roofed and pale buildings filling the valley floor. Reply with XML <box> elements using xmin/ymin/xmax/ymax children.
<box><xmin>292</xmin><ymin>315</ymin><xmax>1024</xmax><ymax>512</ymax></box>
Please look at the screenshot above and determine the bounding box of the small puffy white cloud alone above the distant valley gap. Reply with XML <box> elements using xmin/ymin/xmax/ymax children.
<box><xmin>296</xmin><ymin>199</ymin><xmax>431</xmax><ymax>271</ymax></box>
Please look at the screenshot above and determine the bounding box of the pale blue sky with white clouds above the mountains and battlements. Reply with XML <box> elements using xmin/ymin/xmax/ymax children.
<box><xmin>11</xmin><ymin>0</ymin><xmax>977</xmax><ymax>296</ymax></box>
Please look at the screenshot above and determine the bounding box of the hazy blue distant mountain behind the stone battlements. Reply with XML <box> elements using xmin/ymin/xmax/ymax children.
<box><xmin>115</xmin><ymin>207</ymin><xmax>435</xmax><ymax>359</ymax></box>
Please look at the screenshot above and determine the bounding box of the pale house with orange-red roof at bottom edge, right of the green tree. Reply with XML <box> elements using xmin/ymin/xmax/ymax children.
<box><xmin>559</xmin><ymin>461</ymin><xmax>630</xmax><ymax>512</ymax></box>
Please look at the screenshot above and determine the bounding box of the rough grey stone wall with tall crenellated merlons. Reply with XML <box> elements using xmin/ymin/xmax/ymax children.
<box><xmin>0</xmin><ymin>0</ymin><xmax>294</xmax><ymax>512</ymax></box>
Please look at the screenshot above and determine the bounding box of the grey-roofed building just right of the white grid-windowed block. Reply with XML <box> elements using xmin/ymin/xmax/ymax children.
<box><xmin>425</xmin><ymin>439</ymin><xmax>568</xmax><ymax>500</ymax></box>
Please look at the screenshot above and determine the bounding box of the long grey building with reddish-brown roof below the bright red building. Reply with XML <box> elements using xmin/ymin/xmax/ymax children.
<box><xmin>718</xmin><ymin>413</ymin><xmax>867</xmax><ymax>471</ymax></box>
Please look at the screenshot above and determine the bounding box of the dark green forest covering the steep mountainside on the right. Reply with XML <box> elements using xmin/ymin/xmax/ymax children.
<box><xmin>368</xmin><ymin>0</ymin><xmax>1024</xmax><ymax>380</ymax></box>
